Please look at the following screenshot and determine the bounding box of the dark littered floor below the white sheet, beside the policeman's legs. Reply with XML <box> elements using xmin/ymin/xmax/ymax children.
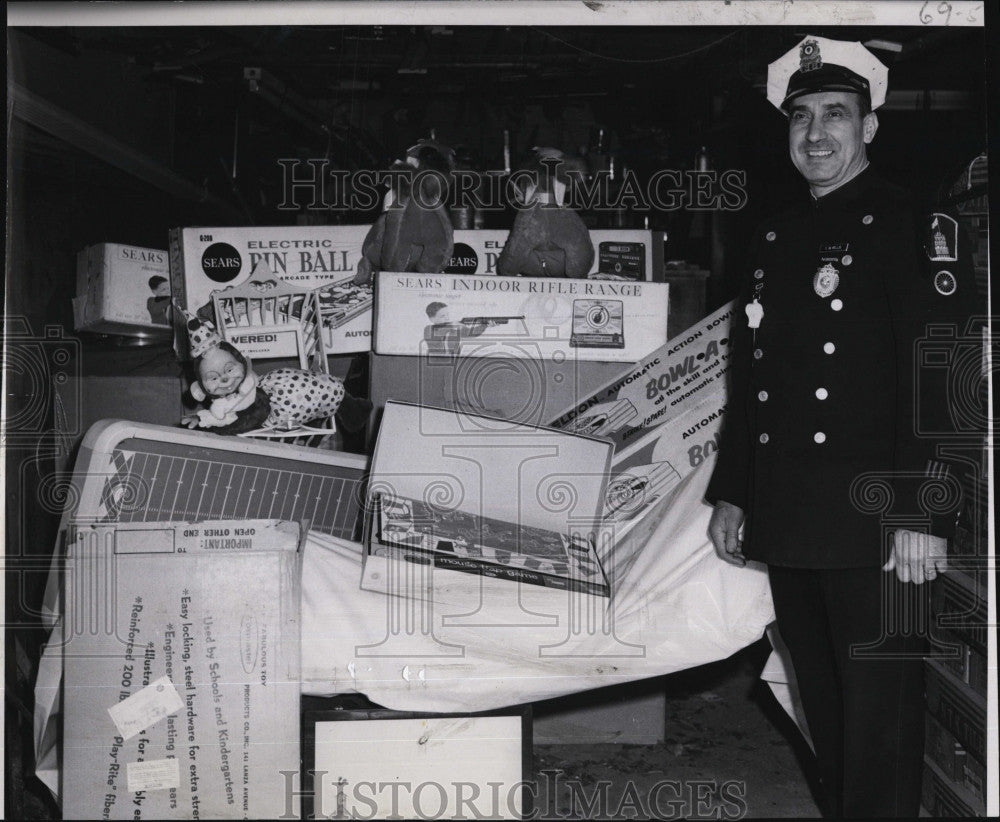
<box><xmin>534</xmin><ymin>641</ymin><xmax>819</xmax><ymax>819</ymax></box>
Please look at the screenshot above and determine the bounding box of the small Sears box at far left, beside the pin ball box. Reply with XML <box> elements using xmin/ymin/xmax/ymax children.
<box><xmin>73</xmin><ymin>243</ymin><xmax>171</xmax><ymax>340</ymax></box>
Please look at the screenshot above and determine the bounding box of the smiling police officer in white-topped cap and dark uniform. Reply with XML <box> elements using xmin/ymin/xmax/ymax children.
<box><xmin>707</xmin><ymin>37</ymin><xmax>975</xmax><ymax>817</ymax></box>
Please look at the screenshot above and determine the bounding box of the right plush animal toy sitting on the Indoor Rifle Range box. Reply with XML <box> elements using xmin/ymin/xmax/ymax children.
<box><xmin>497</xmin><ymin>148</ymin><xmax>594</xmax><ymax>278</ymax></box>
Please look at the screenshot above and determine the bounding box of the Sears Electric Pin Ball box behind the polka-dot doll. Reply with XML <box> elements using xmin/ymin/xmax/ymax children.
<box><xmin>170</xmin><ymin>225</ymin><xmax>371</xmax><ymax>357</ymax></box>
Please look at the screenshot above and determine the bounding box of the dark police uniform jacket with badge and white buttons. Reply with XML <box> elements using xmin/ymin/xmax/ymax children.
<box><xmin>706</xmin><ymin>167</ymin><xmax>975</xmax><ymax>568</ymax></box>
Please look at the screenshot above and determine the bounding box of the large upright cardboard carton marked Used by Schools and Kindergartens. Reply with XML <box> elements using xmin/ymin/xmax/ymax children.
<box><xmin>61</xmin><ymin>520</ymin><xmax>303</xmax><ymax>819</ymax></box>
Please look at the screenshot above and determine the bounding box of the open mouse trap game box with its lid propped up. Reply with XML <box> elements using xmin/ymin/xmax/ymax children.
<box><xmin>361</xmin><ymin>402</ymin><xmax>611</xmax><ymax>610</ymax></box>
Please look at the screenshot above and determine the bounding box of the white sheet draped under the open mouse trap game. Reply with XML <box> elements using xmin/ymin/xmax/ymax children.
<box><xmin>29</xmin><ymin>460</ymin><xmax>782</xmax><ymax>795</ymax></box>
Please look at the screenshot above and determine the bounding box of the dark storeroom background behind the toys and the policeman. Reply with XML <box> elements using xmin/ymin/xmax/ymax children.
<box><xmin>4</xmin><ymin>26</ymin><xmax>987</xmax><ymax>818</ymax></box>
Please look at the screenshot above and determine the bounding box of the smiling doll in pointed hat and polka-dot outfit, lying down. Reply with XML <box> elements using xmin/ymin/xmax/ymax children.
<box><xmin>182</xmin><ymin>314</ymin><xmax>371</xmax><ymax>434</ymax></box>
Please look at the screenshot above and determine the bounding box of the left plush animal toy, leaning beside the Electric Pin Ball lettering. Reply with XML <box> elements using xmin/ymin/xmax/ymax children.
<box><xmin>354</xmin><ymin>140</ymin><xmax>455</xmax><ymax>285</ymax></box>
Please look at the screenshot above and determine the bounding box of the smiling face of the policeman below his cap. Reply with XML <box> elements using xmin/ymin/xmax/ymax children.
<box><xmin>788</xmin><ymin>91</ymin><xmax>878</xmax><ymax>197</ymax></box>
